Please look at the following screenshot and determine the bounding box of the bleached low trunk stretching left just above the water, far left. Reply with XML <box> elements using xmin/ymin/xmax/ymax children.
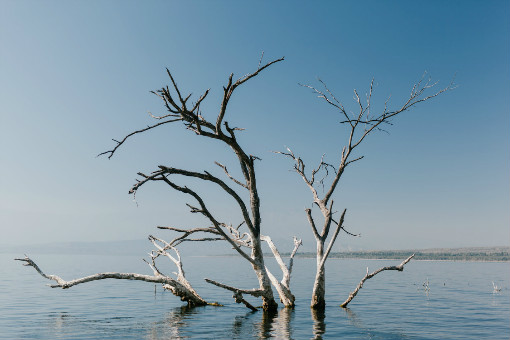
<box><xmin>15</xmin><ymin>236</ymin><xmax>208</xmax><ymax>306</ymax></box>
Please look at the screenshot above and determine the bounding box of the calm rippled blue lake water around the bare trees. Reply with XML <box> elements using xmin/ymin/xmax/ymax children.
<box><xmin>0</xmin><ymin>254</ymin><xmax>510</xmax><ymax>339</ymax></box>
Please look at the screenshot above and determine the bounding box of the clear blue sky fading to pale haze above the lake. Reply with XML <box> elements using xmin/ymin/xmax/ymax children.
<box><xmin>0</xmin><ymin>0</ymin><xmax>510</xmax><ymax>250</ymax></box>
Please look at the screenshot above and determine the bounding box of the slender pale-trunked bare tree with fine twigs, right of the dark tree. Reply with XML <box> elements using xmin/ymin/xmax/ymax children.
<box><xmin>277</xmin><ymin>77</ymin><xmax>454</xmax><ymax>309</ymax></box>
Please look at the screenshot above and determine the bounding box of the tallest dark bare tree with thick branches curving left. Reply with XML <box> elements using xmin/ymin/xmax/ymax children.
<box><xmin>95</xmin><ymin>58</ymin><xmax>297</xmax><ymax>310</ymax></box>
